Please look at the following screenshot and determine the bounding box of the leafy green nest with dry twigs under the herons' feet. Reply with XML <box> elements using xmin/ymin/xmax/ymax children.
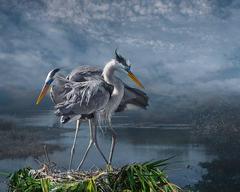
<box><xmin>9</xmin><ymin>160</ymin><xmax>181</xmax><ymax>192</ymax></box>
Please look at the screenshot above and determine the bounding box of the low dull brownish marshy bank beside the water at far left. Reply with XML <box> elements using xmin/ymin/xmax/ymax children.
<box><xmin>0</xmin><ymin>119</ymin><xmax>72</xmax><ymax>159</ymax></box>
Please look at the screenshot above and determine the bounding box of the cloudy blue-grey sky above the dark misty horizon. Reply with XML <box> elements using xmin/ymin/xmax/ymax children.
<box><xmin>0</xmin><ymin>0</ymin><xmax>240</xmax><ymax>109</ymax></box>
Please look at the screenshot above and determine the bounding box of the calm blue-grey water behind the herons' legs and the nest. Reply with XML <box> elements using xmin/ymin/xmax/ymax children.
<box><xmin>0</xmin><ymin>112</ymin><xmax>215</xmax><ymax>191</ymax></box>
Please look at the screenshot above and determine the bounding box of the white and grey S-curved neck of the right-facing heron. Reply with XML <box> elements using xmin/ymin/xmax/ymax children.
<box><xmin>102</xmin><ymin>59</ymin><xmax>124</xmax><ymax>113</ymax></box>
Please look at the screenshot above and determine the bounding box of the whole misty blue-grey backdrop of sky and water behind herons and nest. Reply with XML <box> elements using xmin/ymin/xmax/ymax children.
<box><xmin>0</xmin><ymin>0</ymin><xmax>240</xmax><ymax>192</ymax></box>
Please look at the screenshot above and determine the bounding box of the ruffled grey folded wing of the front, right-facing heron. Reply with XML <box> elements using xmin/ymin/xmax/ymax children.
<box><xmin>55</xmin><ymin>79</ymin><xmax>111</xmax><ymax>116</ymax></box>
